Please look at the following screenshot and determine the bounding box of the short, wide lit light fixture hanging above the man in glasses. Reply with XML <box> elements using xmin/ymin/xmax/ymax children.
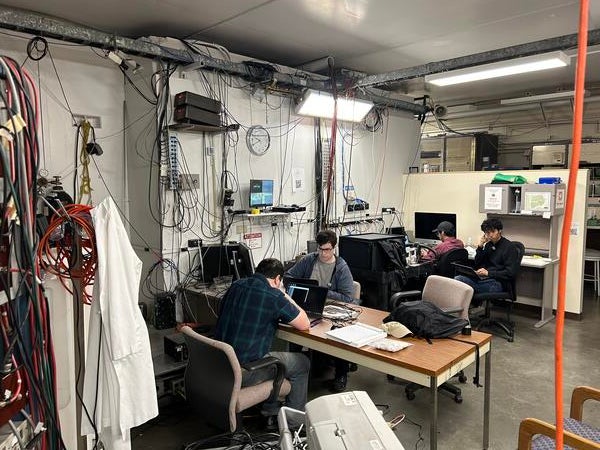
<box><xmin>296</xmin><ymin>90</ymin><xmax>373</xmax><ymax>122</ymax></box>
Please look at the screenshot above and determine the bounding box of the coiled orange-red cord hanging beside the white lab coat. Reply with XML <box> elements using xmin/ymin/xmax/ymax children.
<box><xmin>37</xmin><ymin>204</ymin><xmax>97</xmax><ymax>305</ymax></box>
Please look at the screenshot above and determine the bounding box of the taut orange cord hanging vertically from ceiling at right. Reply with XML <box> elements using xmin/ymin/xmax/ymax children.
<box><xmin>554</xmin><ymin>0</ymin><xmax>589</xmax><ymax>450</ymax></box>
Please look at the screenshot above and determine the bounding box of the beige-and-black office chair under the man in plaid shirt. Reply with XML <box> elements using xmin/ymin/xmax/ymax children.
<box><xmin>181</xmin><ymin>326</ymin><xmax>291</xmax><ymax>432</ymax></box>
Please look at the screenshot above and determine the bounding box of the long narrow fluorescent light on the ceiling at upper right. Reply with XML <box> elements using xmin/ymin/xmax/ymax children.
<box><xmin>425</xmin><ymin>52</ymin><xmax>571</xmax><ymax>86</ymax></box>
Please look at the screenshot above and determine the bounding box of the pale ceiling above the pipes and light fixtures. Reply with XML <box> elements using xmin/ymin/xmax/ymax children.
<box><xmin>0</xmin><ymin>0</ymin><xmax>600</xmax><ymax>106</ymax></box>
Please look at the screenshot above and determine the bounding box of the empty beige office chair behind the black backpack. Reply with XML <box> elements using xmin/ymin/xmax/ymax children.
<box><xmin>388</xmin><ymin>276</ymin><xmax>473</xmax><ymax>403</ymax></box>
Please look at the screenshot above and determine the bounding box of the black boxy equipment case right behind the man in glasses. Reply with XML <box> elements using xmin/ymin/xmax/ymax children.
<box><xmin>339</xmin><ymin>233</ymin><xmax>404</xmax><ymax>272</ymax></box>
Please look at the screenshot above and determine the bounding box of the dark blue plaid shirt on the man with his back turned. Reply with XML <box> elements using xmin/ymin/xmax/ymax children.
<box><xmin>215</xmin><ymin>273</ymin><xmax>300</xmax><ymax>364</ymax></box>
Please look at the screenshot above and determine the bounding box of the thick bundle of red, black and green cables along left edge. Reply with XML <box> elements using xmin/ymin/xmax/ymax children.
<box><xmin>0</xmin><ymin>56</ymin><xmax>65</xmax><ymax>449</ymax></box>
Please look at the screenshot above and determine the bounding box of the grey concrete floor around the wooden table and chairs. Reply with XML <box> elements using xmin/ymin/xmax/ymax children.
<box><xmin>132</xmin><ymin>287</ymin><xmax>600</xmax><ymax>450</ymax></box>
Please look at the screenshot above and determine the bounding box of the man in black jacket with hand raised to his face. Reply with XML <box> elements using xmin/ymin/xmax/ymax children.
<box><xmin>454</xmin><ymin>218</ymin><xmax>519</xmax><ymax>293</ymax></box>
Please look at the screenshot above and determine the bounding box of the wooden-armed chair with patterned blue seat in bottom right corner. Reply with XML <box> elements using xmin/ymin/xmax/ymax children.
<box><xmin>518</xmin><ymin>386</ymin><xmax>600</xmax><ymax>450</ymax></box>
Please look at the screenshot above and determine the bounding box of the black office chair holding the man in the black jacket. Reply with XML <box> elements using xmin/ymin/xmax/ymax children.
<box><xmin>472</xmin><ymin>241</ymin><xmax>525</xmax><ymax>342</ymax></box>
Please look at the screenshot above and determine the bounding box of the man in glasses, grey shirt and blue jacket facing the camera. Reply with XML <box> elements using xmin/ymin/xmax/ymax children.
<box><xmin>286</xmin><ymin>230</ymin><xmax>359</xmax><ymax>392</ymax></box>
